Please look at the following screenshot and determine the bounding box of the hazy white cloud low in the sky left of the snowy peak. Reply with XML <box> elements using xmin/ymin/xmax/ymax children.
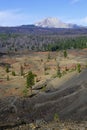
<box><xmin>0</xmin><ymin>9</ymin><xmax>33</xmax><ymax>26</ymax></box>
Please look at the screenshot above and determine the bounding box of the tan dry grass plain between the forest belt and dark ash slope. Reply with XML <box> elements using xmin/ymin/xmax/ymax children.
<box><xmin>0</xmin><ymin>50</ymin><xmax>86</xmax><ymax>97</ymax></box>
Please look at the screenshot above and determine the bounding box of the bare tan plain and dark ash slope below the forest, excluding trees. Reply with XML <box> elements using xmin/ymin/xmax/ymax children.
<box><xmin>0</xmin><ymin>52</ymin><xmax>87</xmax><ymax>129</ymax></box>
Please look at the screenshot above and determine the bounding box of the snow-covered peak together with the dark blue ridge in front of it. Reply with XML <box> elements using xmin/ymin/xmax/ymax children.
<box><xmin>0</xmin><ymin>17</ymin><xmax>87</xmax><ymax>35</ymax></box>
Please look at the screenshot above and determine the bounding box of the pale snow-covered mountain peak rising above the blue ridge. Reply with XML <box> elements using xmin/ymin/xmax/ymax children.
<box><xmin>34</xmin><ymin>17</ymin><xmax>80</xmax><ymax>28</ymax></box>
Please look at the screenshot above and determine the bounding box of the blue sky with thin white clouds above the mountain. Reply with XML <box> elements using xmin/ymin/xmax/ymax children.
<box><xmin>0</xmin><ymin>0</ymin><xmax>87</xmax><ymax>26</ymax></box>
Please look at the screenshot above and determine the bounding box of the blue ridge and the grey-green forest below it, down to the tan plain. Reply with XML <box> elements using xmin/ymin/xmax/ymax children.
<box><xmin>0</xmin><ymin>25</ymin><xmax>87</xmax><ymax>52</ymax></box>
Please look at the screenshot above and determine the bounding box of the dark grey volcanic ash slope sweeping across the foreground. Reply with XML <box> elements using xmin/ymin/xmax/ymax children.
<box><xmin>0</xmin><ymin>70</ymin><xmax>87</xmax><ymax>126</ymax></box>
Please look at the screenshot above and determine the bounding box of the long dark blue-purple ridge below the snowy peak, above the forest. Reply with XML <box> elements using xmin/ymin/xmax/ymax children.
<box><xmin>0</xmin><ymin>25</ymin><xmax>87</xmax><ymax>35</ymax></box>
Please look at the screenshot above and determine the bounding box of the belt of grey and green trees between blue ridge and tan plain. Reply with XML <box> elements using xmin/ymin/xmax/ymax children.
<box><xmin>0</xmin><ymin>34</ymin><xmax>87</xmax><ymax>52</ymax></box>
